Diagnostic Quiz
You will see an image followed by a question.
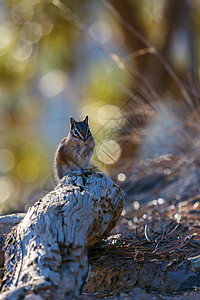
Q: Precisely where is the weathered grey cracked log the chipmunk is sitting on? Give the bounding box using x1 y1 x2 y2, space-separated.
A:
1 170 124 299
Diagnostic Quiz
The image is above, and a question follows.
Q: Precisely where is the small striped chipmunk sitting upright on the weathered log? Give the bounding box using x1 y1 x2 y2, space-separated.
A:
54 116 95 182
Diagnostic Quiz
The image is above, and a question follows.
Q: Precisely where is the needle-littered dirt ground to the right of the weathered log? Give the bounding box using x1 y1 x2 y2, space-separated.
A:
84 155 200 299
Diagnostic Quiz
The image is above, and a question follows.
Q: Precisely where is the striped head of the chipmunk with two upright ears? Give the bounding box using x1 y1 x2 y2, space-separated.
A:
70 115 93 142
